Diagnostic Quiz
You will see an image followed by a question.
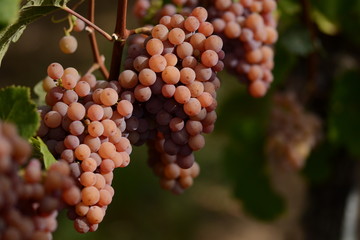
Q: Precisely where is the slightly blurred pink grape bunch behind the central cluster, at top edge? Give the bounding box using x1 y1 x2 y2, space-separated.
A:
134 0 278 97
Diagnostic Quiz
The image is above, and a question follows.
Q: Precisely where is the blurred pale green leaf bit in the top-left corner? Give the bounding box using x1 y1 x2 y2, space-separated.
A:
0 0 20 31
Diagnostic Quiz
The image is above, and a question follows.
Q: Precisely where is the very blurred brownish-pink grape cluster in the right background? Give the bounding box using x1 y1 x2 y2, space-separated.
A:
267 92 322 169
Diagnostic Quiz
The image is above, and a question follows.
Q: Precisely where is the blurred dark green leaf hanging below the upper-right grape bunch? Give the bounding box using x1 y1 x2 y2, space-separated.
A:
217 89 285 220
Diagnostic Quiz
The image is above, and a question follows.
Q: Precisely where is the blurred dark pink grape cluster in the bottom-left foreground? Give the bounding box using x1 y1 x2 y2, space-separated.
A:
0 122 79 240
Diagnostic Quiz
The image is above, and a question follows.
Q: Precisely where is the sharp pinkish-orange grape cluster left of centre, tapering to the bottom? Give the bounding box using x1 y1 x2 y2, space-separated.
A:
38 63 133 233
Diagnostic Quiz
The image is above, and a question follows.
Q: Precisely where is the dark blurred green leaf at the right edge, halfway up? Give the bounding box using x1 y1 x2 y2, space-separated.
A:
328 71 360 156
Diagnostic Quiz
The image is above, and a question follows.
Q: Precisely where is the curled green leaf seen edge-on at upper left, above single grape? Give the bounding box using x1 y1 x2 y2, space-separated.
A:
0 0 69 66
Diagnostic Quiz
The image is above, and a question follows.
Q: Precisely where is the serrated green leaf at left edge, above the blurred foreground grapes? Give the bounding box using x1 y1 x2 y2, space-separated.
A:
0 86 40 139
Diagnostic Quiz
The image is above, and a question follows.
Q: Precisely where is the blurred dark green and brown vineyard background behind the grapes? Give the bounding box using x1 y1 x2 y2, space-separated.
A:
0 0 360 240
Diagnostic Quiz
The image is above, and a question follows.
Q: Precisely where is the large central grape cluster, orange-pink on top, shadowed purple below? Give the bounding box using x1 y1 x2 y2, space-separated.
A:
119 7 221 192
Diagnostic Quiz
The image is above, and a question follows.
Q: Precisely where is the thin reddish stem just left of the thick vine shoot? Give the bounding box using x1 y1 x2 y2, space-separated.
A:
88 0 109 79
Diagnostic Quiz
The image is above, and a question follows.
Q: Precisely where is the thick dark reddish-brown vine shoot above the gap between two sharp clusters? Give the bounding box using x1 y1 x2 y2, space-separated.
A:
108 0 130 80
